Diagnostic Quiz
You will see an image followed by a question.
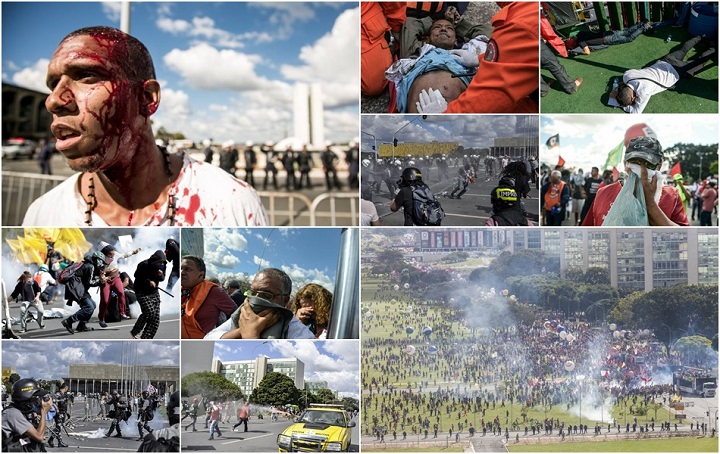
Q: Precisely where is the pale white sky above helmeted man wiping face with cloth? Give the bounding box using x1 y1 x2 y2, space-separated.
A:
540 115 718 172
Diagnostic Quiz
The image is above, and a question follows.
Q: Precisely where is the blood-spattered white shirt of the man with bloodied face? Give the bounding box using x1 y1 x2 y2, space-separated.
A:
22 155 268 227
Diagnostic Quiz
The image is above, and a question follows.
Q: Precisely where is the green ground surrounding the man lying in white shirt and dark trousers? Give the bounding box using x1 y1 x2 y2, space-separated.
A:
541 27 718 114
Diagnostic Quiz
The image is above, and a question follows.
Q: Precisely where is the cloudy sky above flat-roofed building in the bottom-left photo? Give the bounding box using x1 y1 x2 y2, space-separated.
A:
2 340 180 380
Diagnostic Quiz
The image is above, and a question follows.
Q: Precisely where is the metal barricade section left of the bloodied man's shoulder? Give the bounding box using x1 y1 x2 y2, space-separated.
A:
2 171 67 226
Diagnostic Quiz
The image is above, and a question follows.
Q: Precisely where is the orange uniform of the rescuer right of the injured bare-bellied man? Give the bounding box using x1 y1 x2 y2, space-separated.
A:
445 2 539 113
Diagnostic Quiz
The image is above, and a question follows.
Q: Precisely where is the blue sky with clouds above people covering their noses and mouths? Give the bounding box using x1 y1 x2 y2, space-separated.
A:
197 228 342 291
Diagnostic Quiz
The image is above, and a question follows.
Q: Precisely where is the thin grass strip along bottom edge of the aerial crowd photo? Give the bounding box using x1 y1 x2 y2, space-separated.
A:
508 437 718 452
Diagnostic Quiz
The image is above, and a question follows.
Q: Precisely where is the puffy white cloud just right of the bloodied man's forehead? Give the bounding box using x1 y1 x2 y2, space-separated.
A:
163 43 272 91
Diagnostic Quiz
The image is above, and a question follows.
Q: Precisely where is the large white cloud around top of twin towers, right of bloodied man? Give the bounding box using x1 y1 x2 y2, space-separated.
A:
281 8 360 107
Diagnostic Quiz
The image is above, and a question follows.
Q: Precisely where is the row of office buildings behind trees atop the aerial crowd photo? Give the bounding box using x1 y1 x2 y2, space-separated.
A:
415 227 718 291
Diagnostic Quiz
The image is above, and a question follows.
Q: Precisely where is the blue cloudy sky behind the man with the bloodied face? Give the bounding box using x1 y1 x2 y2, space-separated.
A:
2 2 360 143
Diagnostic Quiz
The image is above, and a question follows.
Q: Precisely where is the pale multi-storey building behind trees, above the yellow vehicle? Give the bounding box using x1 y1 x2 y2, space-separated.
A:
211 356 305 396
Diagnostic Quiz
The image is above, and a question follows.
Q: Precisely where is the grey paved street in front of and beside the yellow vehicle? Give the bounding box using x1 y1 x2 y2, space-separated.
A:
181 417 360 452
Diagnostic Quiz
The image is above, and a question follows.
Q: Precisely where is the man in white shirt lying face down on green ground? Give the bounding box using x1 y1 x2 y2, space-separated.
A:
610 36 715 113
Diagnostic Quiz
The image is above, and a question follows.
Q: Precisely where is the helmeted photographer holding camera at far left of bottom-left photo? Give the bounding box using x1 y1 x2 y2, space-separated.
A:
2 378 53 452
